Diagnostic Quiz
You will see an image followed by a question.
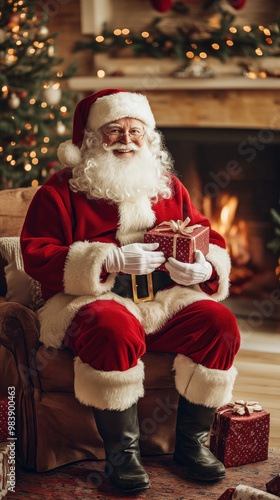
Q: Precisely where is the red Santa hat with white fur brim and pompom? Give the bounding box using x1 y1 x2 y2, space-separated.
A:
57 89 155 167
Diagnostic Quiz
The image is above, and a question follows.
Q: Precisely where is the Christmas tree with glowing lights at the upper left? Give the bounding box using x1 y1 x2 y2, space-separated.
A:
0 0 79 189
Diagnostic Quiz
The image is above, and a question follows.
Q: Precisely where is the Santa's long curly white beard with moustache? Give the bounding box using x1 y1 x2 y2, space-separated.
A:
69 143 171 203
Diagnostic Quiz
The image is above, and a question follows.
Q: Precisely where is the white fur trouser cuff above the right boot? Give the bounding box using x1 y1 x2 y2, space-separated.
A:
174 354 237 408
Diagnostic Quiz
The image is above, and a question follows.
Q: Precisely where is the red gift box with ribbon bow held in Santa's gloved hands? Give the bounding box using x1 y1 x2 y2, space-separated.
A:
144 217 209 272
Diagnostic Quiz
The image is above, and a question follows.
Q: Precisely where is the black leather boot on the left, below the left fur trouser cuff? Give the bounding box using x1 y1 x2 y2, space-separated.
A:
93 403 150 493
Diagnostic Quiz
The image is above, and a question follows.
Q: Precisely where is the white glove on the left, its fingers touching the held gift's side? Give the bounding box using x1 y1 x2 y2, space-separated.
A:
105 243 165 274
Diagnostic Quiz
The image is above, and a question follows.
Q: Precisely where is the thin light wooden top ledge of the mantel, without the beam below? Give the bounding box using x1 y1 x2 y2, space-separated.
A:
69 74 280 92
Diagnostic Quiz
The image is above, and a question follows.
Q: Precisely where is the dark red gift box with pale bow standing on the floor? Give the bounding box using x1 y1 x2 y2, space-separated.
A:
210 401 270 467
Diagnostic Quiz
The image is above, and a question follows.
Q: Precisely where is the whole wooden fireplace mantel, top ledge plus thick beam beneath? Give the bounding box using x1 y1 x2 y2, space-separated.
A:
69 75 280 130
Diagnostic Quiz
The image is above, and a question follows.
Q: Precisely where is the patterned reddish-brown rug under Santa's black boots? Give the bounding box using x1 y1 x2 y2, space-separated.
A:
6 450 280 500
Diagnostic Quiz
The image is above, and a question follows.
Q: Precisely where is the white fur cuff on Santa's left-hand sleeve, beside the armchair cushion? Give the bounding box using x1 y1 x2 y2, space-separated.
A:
63 241 115 296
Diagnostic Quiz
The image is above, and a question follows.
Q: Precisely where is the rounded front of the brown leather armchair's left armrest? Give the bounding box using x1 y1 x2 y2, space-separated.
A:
0 302 40 469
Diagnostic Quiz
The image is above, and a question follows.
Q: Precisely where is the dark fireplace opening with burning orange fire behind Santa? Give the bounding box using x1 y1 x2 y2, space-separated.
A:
161 127 280 328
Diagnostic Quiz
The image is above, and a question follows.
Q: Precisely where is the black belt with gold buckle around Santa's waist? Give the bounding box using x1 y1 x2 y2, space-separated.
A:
112 271 175 302
